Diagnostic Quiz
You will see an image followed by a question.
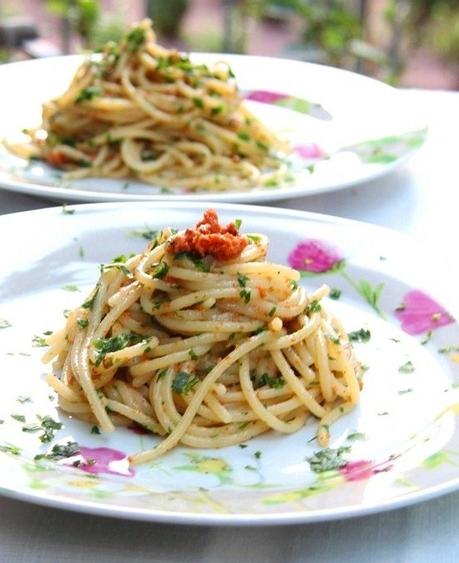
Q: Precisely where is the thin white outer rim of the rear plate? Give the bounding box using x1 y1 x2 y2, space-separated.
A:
0 51 429 203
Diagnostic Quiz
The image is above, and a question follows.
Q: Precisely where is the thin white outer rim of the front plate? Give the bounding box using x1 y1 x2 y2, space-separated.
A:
0 201 459 526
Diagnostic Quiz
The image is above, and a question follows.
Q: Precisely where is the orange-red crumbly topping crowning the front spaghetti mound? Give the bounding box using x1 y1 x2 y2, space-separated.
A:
168 209 248 260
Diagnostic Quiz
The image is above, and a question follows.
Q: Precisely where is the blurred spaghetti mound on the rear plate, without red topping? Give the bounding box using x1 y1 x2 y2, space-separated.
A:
8 20 289 191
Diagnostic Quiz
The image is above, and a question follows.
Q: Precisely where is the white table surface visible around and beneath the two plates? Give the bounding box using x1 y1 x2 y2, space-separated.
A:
0 90 459 563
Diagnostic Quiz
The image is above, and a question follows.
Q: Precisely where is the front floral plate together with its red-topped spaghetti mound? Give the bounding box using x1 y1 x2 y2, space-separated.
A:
0 202 459 525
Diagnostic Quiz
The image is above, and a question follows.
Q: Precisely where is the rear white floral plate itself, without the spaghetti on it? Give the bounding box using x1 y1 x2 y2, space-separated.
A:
0 54 426 202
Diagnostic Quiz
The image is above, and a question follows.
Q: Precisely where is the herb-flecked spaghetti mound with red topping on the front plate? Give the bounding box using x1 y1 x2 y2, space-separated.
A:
45 210 361 463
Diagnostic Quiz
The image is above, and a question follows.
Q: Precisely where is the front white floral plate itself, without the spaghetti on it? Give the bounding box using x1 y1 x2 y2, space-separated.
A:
0 202 459 525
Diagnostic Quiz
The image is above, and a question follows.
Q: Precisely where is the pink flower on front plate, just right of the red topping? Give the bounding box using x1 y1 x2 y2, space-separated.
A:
287 239 342 273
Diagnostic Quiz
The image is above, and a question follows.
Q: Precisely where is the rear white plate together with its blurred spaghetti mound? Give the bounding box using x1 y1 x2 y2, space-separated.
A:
0 20 426 201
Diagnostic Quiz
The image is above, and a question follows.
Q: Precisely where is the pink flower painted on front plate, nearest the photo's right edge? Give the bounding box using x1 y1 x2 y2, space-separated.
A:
395 289 454 334
